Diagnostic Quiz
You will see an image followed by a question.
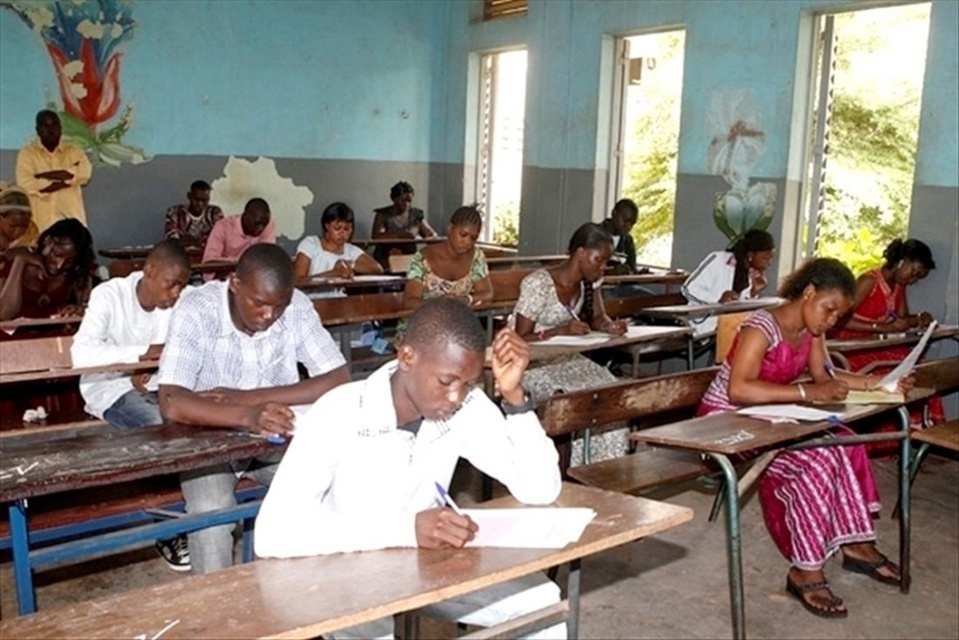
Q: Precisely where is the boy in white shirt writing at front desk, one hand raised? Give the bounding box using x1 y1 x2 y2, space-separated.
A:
255 298 566 638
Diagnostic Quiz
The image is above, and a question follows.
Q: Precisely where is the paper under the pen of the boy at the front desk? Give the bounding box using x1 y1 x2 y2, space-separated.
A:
463 507 596 549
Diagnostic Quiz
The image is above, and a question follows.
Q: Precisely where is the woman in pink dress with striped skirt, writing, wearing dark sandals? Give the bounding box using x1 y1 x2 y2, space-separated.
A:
699 258 911 618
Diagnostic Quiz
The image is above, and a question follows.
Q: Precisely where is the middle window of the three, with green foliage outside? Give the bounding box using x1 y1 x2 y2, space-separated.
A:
606 30 686 266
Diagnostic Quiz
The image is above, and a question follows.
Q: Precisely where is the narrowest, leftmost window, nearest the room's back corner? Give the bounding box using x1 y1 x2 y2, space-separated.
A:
467 50 526 246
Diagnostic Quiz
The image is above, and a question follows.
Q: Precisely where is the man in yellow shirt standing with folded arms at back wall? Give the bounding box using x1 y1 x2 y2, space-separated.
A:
17 110 93 233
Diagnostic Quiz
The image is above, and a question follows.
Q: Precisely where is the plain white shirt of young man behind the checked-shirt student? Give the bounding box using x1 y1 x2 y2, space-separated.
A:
70 271 173 419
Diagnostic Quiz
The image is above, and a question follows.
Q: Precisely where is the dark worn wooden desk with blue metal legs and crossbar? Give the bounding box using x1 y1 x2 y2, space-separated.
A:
0 425 283 612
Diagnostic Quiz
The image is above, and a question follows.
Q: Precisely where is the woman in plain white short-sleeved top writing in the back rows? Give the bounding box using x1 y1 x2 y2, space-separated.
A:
293 202 383 295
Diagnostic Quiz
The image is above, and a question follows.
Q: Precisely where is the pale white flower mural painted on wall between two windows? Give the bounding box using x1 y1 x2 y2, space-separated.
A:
706 90 776 243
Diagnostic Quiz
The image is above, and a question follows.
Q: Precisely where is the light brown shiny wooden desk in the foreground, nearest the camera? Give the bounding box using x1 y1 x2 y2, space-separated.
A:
0 484 693 639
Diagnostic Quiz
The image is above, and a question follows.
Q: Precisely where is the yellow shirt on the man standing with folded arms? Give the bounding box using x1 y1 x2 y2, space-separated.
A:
17 140 93 233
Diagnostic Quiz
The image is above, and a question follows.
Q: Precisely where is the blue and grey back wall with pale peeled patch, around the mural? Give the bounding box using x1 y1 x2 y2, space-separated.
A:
0 0 444 247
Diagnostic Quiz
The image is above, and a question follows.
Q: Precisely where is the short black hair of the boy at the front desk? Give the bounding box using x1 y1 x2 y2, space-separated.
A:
403 296 486 353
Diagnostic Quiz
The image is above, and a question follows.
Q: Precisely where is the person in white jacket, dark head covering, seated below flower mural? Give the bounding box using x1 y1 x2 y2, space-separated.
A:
682 229 776 334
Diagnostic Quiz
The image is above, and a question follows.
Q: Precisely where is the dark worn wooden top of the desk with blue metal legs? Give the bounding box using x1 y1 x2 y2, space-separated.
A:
0 424 284 502
